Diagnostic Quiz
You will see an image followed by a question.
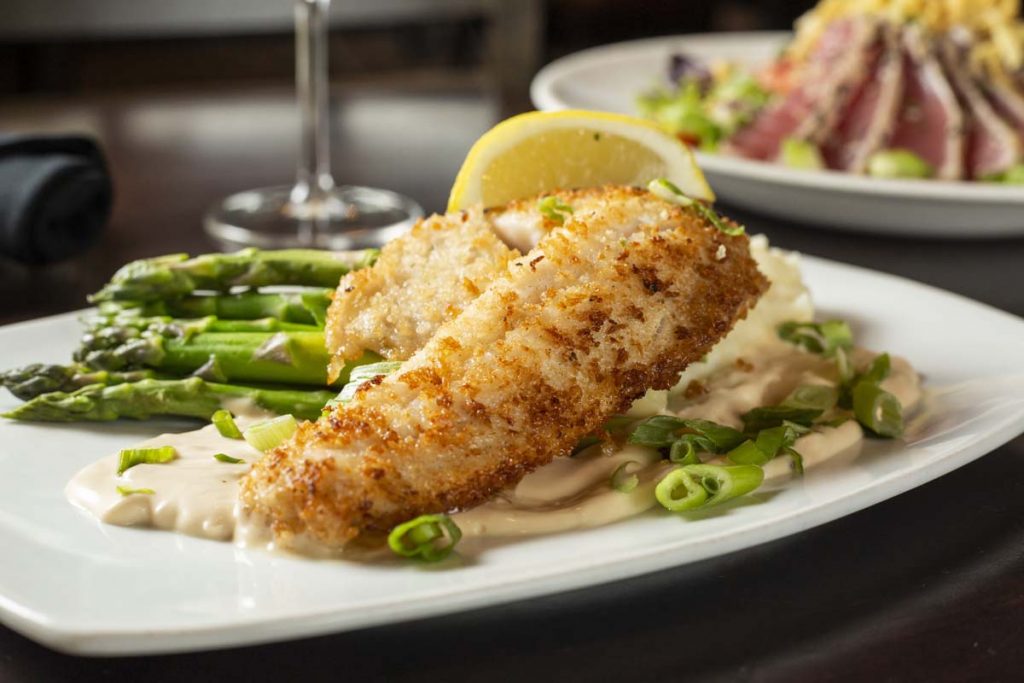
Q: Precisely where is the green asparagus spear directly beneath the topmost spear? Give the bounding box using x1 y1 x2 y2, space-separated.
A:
99 289 332 327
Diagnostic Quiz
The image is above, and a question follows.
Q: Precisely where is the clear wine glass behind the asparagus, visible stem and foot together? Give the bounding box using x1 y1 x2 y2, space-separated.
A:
204 0 423 250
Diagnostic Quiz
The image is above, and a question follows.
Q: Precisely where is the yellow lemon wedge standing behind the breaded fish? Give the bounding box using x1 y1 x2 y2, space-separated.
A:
447 110 715 211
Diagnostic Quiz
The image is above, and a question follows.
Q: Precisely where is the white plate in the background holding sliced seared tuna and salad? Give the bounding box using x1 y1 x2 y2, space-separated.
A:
530 32 1024 238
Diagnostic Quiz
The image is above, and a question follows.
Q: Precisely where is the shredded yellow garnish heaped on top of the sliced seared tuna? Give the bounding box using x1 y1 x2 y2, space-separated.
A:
787 0 1024 75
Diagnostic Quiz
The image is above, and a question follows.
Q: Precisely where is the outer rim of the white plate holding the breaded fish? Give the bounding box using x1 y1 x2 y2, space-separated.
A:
0 255 1024 655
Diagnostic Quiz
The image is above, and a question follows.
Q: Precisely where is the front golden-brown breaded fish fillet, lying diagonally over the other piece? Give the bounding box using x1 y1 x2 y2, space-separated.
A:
241 187 767 547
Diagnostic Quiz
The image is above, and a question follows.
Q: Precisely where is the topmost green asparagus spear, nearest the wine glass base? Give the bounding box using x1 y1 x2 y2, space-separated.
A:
89 249 378 303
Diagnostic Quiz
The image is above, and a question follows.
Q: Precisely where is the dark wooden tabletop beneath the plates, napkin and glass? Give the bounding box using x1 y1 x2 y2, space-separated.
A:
0 89 1024 683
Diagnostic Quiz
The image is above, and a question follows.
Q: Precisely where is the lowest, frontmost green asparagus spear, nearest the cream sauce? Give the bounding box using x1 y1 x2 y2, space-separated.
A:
3 377 336 422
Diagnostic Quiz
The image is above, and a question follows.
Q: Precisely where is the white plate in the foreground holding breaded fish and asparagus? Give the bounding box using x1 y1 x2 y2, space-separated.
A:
0 258 1024 654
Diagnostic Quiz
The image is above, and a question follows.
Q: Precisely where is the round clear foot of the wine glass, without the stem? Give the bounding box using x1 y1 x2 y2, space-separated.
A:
203 185 423 251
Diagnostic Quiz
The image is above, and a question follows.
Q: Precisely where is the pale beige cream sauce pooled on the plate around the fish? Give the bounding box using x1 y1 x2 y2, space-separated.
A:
67 342 921 555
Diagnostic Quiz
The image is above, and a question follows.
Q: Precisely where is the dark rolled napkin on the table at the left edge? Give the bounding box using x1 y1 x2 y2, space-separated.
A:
0 133 114 264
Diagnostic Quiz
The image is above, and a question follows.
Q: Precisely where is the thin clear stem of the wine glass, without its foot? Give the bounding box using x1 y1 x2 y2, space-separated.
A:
292 0 334 204
